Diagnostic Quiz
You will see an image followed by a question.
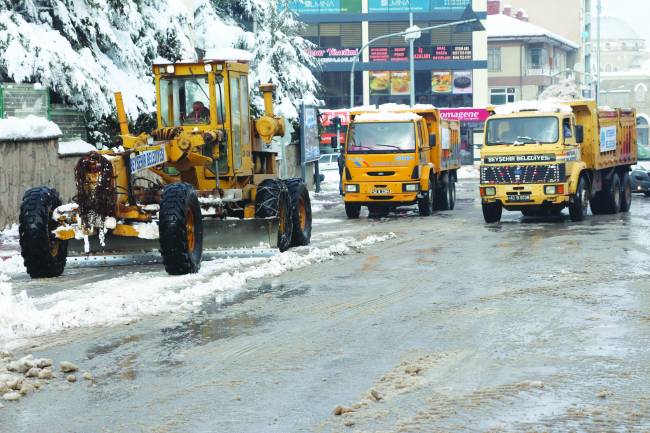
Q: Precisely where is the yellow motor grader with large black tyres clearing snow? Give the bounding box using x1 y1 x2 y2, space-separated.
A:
19 54 311 278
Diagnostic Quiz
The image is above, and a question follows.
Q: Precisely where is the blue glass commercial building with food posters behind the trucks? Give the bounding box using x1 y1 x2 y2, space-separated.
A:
291 0 487 109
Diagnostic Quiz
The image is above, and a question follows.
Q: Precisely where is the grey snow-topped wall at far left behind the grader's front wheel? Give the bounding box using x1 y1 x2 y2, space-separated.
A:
0 138 79 229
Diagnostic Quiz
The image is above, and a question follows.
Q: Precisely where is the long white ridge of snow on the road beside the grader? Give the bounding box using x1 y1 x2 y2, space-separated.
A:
0 233 395 348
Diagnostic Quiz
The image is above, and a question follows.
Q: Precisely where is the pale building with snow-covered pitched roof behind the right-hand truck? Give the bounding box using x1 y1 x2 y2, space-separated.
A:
486 8 579 104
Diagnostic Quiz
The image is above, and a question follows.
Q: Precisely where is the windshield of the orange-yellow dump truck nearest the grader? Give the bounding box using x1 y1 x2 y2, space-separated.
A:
347 122 415 153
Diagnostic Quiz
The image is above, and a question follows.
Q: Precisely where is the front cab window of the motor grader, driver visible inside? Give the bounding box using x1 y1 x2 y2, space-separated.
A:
160 74 222 126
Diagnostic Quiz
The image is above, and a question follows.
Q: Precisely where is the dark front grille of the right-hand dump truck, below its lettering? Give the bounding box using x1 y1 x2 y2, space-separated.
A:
481 164 566 184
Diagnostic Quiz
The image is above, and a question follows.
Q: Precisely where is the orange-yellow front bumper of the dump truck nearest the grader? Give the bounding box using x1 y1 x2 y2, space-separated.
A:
343 180 420 205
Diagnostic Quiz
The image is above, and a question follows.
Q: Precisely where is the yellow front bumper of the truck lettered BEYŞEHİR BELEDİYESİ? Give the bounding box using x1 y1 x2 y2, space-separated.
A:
480 183 571 209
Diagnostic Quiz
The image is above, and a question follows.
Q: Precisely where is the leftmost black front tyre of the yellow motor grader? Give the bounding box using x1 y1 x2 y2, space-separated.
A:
18 186 68 278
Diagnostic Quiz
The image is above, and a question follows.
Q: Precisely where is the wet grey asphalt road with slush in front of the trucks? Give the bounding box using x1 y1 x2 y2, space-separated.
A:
0 177 650 433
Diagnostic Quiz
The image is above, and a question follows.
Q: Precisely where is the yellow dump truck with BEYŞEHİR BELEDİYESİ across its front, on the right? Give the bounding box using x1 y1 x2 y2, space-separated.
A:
480 101 637 223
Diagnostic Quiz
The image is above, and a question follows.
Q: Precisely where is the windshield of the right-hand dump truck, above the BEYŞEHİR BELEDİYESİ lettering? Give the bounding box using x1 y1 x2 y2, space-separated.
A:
486 116 559 146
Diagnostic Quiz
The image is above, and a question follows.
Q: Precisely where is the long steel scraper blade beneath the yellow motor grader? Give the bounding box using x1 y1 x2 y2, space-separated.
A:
68 218 278 256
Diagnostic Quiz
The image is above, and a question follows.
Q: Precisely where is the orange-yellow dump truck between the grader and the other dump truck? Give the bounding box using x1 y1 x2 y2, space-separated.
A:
341 106 460 218
